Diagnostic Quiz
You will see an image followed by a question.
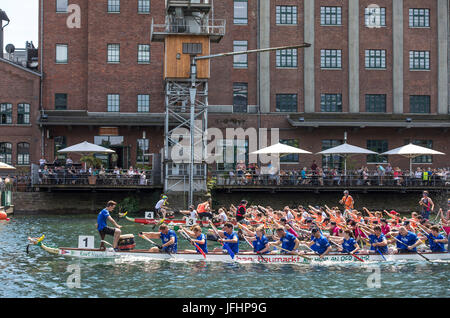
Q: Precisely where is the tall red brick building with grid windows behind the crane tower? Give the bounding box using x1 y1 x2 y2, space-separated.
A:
19 0 450 176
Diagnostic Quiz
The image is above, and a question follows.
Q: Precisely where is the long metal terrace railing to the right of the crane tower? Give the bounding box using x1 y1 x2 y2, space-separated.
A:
212 171 450 188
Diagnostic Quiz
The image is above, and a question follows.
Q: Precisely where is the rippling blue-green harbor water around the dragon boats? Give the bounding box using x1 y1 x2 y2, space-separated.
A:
0 215 450 298
